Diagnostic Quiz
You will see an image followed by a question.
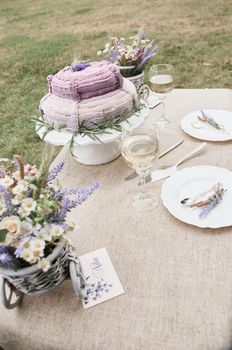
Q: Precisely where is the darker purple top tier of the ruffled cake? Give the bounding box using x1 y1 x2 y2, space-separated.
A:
47 61 123 102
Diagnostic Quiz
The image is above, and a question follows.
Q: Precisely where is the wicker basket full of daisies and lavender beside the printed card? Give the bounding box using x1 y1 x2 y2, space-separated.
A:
0 156 98 308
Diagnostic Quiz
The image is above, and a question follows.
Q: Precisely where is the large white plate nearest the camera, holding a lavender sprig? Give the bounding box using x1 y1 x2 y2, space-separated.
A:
161 165 232 228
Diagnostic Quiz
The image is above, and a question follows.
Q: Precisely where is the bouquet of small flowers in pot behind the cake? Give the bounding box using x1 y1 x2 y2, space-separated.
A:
97 30 157 87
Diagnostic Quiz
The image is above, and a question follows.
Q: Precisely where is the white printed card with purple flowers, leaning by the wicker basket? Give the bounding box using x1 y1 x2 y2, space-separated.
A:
79 248 125 309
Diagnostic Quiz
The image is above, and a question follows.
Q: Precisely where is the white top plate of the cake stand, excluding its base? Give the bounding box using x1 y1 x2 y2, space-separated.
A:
36 105 149 146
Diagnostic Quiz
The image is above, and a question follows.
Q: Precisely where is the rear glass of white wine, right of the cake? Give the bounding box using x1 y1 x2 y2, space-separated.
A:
150 64 174 128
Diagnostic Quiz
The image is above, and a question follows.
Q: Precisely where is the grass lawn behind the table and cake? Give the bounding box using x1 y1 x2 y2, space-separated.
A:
0 0 232 164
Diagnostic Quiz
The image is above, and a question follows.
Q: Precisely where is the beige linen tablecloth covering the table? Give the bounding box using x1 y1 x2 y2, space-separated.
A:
0 89 232 350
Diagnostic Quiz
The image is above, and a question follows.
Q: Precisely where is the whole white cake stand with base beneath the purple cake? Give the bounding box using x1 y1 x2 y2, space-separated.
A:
36 106 149 165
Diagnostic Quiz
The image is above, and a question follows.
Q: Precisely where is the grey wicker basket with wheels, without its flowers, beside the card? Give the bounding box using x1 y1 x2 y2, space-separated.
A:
0 241 84 309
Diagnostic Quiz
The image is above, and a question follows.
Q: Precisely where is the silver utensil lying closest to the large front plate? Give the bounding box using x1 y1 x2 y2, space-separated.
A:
139 142 207 185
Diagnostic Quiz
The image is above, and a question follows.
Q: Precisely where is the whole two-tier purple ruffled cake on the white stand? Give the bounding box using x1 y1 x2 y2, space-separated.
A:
40 61 136 132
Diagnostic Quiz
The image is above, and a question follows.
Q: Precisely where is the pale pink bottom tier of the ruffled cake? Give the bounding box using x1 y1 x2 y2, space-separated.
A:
40 78 136 132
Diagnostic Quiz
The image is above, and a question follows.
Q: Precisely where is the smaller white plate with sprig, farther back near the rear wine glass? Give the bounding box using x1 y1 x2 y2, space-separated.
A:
181 109 232 141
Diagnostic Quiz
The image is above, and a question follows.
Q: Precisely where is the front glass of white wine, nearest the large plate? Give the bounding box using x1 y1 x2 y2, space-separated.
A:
122 122 159 212
